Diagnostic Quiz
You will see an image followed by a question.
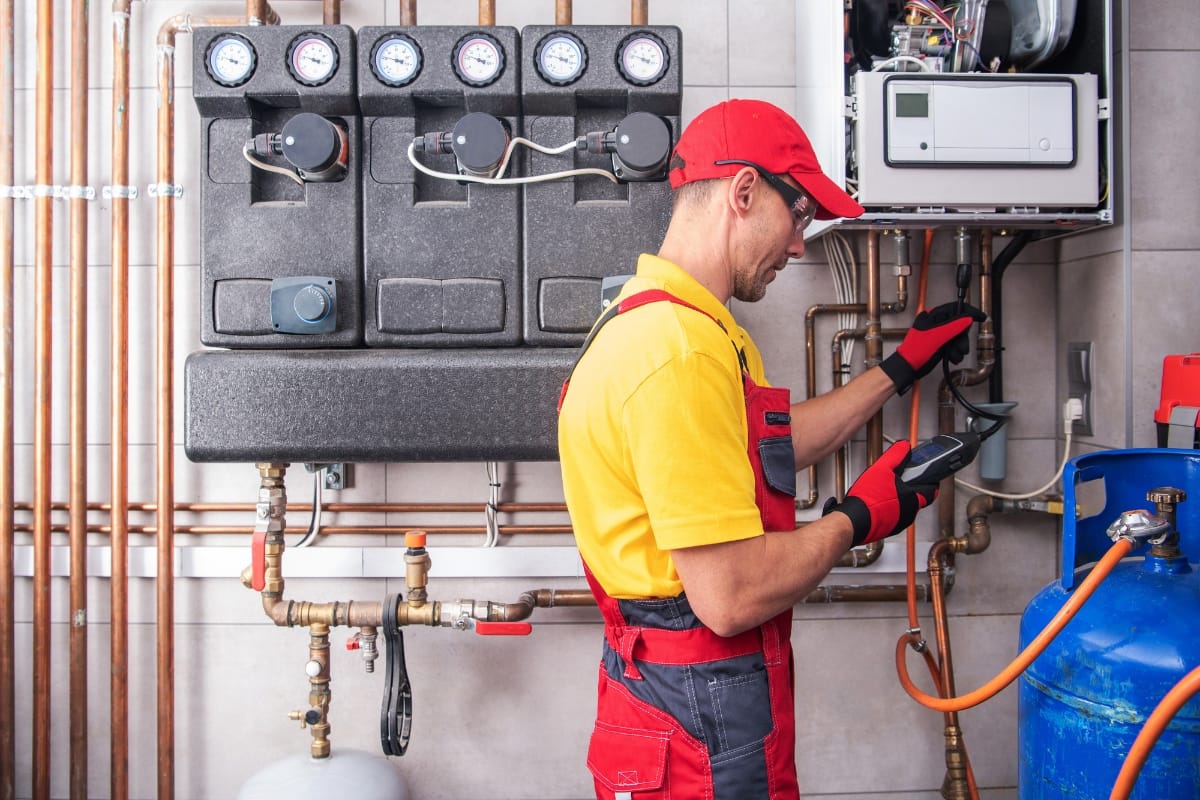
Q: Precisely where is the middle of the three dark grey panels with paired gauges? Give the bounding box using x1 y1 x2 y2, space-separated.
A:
358 25 521 348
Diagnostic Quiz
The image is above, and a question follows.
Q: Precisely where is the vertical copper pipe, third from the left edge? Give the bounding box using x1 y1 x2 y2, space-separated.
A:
68 0 88 786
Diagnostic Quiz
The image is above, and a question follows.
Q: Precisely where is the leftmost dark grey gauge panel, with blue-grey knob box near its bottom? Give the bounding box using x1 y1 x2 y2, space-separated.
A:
192 25 362 348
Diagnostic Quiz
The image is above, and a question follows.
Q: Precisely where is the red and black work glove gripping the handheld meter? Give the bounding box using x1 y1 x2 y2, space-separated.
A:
822 441 937 547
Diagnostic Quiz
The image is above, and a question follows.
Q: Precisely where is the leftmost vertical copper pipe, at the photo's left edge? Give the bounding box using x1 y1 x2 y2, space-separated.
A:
0 0 17 800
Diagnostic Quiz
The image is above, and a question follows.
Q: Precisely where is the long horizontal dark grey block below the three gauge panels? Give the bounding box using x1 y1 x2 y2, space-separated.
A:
184 348 576 462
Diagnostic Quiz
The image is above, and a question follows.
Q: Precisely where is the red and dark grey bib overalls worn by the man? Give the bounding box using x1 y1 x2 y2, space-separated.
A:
559 290 799 800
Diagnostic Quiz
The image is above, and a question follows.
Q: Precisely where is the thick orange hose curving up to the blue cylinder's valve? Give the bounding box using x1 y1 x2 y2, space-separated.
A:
896 539 1133 711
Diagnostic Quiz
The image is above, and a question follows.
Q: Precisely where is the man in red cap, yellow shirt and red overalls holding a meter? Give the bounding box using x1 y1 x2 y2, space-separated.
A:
559 100 982 800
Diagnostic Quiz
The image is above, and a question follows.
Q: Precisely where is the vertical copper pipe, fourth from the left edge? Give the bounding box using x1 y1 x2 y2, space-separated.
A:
108 0 132 800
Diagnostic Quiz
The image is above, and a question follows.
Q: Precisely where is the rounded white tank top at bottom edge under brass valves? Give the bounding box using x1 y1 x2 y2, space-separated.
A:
238 748 413 800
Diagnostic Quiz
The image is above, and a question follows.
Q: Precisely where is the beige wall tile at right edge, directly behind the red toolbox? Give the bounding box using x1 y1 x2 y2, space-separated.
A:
1130 251 1200 447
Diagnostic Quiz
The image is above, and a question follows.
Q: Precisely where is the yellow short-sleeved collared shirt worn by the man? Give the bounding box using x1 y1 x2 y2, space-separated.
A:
558 254 766 599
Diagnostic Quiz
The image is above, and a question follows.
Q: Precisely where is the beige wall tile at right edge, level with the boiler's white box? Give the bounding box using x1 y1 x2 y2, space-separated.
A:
1130 50 1200 251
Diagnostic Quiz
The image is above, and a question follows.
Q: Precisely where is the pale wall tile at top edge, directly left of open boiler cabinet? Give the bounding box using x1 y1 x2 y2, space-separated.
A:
728 0 796 86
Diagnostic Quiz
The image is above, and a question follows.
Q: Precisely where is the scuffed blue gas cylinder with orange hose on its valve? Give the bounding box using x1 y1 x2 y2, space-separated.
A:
1018 450 1200 800
